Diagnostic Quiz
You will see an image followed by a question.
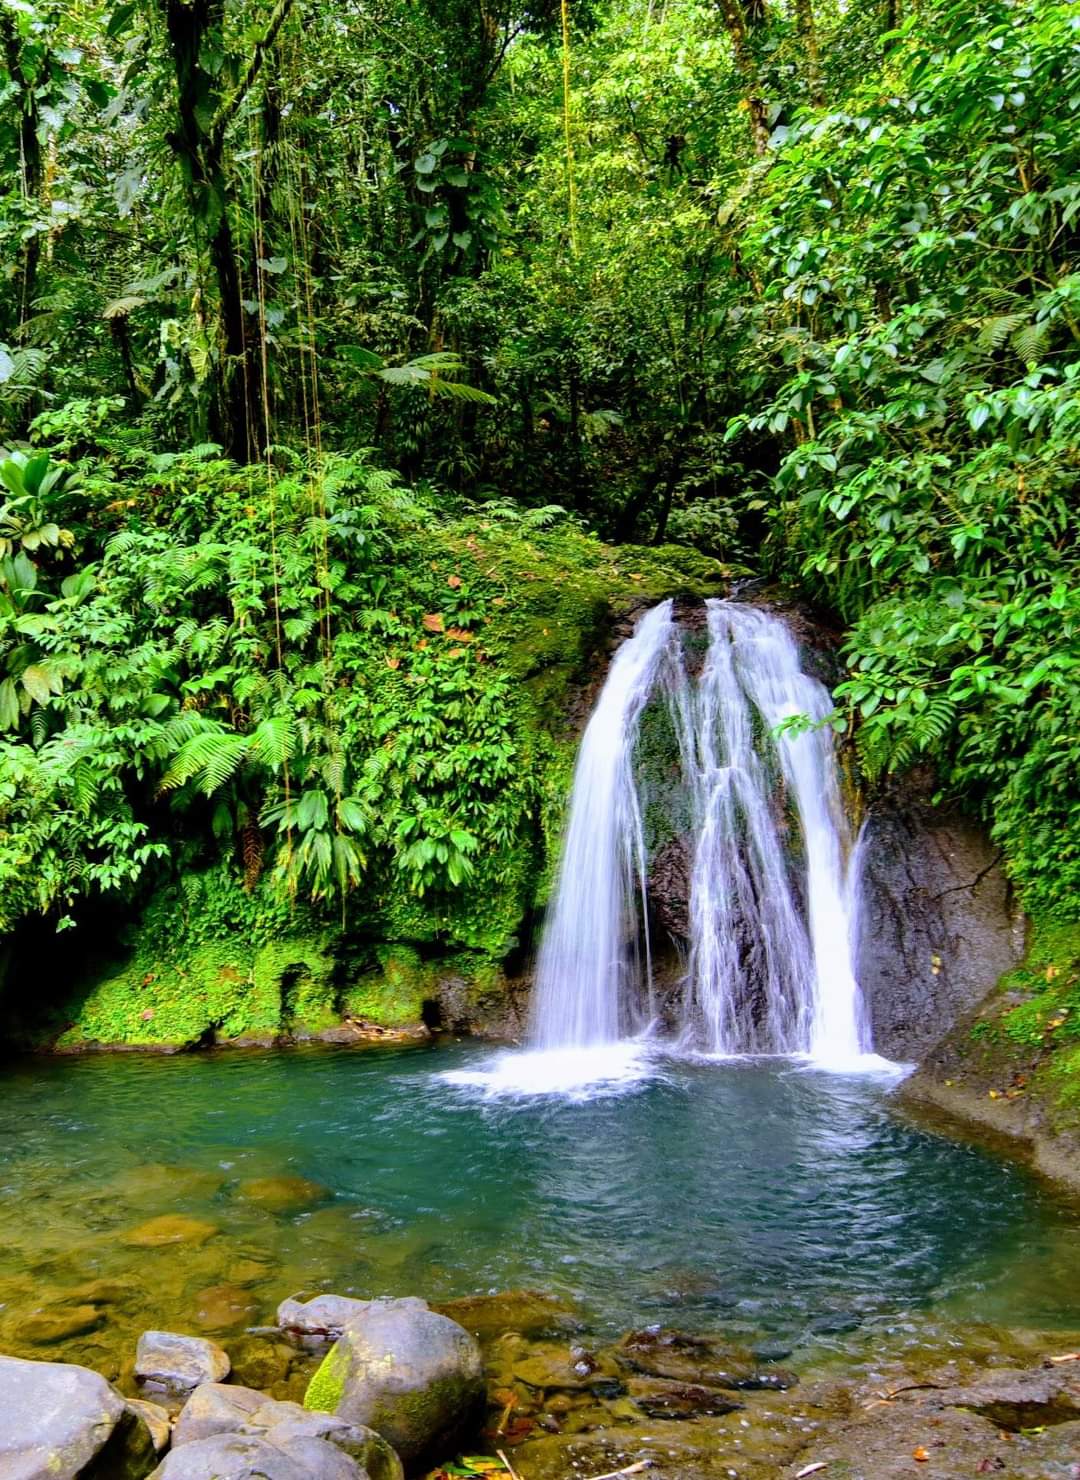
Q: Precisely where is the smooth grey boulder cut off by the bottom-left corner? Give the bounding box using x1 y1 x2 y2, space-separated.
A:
0 1357 154 1480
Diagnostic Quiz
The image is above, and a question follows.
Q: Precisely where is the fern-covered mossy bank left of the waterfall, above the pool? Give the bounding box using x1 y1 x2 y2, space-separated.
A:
0 435 725 1043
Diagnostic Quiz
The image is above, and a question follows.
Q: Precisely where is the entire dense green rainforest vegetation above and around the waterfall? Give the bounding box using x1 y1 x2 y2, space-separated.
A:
0 0 1080 1032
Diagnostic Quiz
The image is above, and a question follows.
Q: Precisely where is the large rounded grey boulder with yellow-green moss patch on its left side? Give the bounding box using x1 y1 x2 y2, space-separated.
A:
305 1299 484 1465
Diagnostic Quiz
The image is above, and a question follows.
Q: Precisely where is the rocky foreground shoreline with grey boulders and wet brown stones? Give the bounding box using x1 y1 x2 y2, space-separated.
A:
0 1291 1080 1480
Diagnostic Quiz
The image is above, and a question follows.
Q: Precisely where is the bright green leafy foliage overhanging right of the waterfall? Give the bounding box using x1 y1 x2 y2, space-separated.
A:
728 3 1080 919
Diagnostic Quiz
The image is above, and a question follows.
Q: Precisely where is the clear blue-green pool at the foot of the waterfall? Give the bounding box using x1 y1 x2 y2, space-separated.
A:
0 1045 1080 1362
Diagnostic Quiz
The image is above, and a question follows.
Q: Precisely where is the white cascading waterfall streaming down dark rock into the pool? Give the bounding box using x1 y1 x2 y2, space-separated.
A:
530 601 870 1063
